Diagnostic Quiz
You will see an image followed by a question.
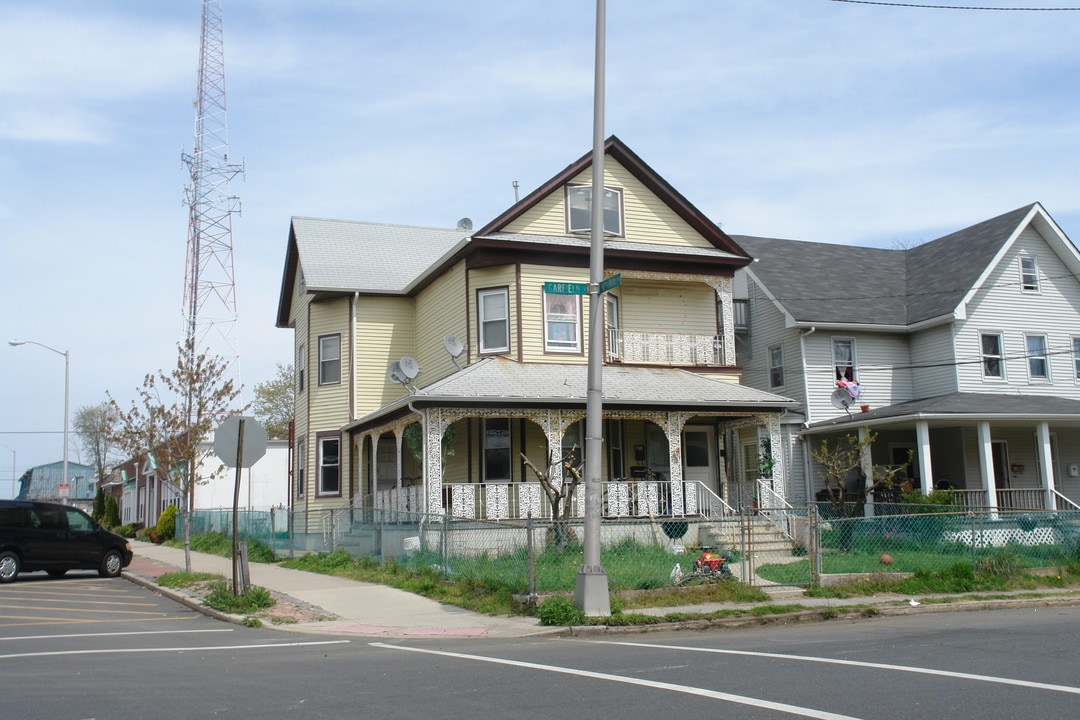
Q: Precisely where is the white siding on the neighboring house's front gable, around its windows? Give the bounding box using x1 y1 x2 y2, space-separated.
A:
956 228 1080 399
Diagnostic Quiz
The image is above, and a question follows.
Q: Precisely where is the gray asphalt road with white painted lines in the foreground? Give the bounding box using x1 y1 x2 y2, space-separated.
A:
0 576 1080 720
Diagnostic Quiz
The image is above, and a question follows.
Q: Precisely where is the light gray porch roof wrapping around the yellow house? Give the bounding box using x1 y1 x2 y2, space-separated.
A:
345 357 797 431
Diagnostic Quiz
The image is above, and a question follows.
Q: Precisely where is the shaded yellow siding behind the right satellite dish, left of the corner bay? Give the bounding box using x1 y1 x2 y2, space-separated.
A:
415 262 469 386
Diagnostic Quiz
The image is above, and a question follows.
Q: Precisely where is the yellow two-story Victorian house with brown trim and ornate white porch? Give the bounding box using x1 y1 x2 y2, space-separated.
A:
278 137 794 539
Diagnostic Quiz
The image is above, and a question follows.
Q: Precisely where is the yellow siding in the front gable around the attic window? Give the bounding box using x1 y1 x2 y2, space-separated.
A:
507 158 712 247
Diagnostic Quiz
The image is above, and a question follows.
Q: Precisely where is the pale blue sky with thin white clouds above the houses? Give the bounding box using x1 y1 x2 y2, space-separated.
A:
0 0 1080 497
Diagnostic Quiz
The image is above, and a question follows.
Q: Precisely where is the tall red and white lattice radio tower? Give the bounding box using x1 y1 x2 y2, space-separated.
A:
181 0 244 395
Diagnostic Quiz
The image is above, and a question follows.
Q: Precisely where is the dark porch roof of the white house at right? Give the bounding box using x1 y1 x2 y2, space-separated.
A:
804 393 1080 435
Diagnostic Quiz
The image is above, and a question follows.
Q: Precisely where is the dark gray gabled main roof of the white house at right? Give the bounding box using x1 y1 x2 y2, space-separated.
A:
733 203 1080 329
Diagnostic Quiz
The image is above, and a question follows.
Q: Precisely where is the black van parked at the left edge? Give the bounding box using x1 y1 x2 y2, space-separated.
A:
0 500 132 583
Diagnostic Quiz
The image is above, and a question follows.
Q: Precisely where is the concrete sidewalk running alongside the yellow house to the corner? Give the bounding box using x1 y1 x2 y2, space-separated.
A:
124 541 562 638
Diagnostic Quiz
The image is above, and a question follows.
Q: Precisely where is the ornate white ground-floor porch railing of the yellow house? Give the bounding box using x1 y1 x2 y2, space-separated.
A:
370 479 735 520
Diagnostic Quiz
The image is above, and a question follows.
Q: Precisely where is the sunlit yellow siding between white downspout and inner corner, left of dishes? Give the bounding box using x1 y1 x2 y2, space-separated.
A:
356 297 416 417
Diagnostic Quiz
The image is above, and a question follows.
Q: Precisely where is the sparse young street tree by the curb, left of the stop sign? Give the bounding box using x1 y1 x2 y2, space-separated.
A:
109 340 241 572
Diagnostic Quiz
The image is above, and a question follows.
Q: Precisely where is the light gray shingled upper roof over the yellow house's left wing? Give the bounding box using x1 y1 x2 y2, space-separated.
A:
293 217 469 294
